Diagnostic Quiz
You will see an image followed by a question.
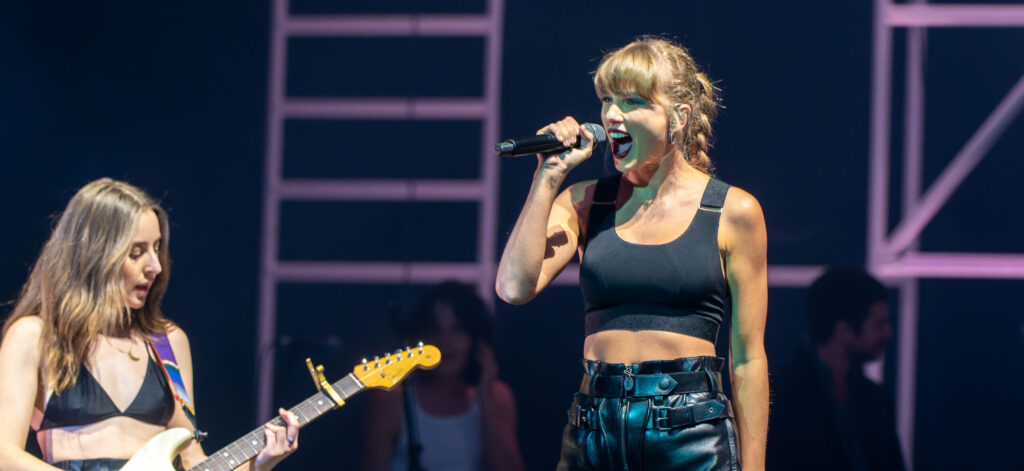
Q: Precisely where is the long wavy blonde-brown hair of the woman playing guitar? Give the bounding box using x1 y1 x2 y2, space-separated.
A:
3 178 170 393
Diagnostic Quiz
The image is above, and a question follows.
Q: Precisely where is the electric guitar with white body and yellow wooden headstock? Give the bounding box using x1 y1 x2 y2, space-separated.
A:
120 343 441 471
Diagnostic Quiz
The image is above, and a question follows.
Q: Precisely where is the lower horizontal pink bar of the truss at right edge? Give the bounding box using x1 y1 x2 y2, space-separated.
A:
874 253 1024 280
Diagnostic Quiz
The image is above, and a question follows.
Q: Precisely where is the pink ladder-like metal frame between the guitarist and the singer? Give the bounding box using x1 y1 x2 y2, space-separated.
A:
255 0 505 418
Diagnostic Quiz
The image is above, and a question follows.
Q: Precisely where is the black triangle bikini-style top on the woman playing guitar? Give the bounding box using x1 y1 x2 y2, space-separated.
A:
39 357 174 430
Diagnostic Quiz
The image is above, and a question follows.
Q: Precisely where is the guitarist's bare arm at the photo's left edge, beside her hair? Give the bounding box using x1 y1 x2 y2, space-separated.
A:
0 315 57 471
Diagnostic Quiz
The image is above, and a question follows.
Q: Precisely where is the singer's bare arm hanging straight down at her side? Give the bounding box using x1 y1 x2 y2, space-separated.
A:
719 187 768 471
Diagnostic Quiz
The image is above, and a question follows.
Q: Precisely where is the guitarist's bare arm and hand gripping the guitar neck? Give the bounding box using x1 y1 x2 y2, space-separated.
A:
167 326 299 471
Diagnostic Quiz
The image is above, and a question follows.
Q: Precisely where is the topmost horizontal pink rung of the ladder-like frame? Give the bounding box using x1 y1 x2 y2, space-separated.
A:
285 14 493 37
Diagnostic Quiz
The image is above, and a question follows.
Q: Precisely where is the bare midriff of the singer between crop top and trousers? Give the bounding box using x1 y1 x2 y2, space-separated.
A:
583 331 715 363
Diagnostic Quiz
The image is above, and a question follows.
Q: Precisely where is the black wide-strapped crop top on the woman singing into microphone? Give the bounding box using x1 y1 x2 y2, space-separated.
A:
580 175 729 343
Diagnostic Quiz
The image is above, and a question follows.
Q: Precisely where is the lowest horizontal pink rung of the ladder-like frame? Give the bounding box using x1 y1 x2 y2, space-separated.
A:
268 261 480 285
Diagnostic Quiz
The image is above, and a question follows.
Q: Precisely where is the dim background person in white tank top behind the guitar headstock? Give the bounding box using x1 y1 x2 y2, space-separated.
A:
362 282 523 471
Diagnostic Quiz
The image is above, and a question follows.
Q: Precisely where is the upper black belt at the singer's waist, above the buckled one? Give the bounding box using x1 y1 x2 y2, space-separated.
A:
580 372 721 397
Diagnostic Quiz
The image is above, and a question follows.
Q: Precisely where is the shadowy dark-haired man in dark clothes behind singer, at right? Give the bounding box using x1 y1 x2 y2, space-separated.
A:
768 268 903 471
